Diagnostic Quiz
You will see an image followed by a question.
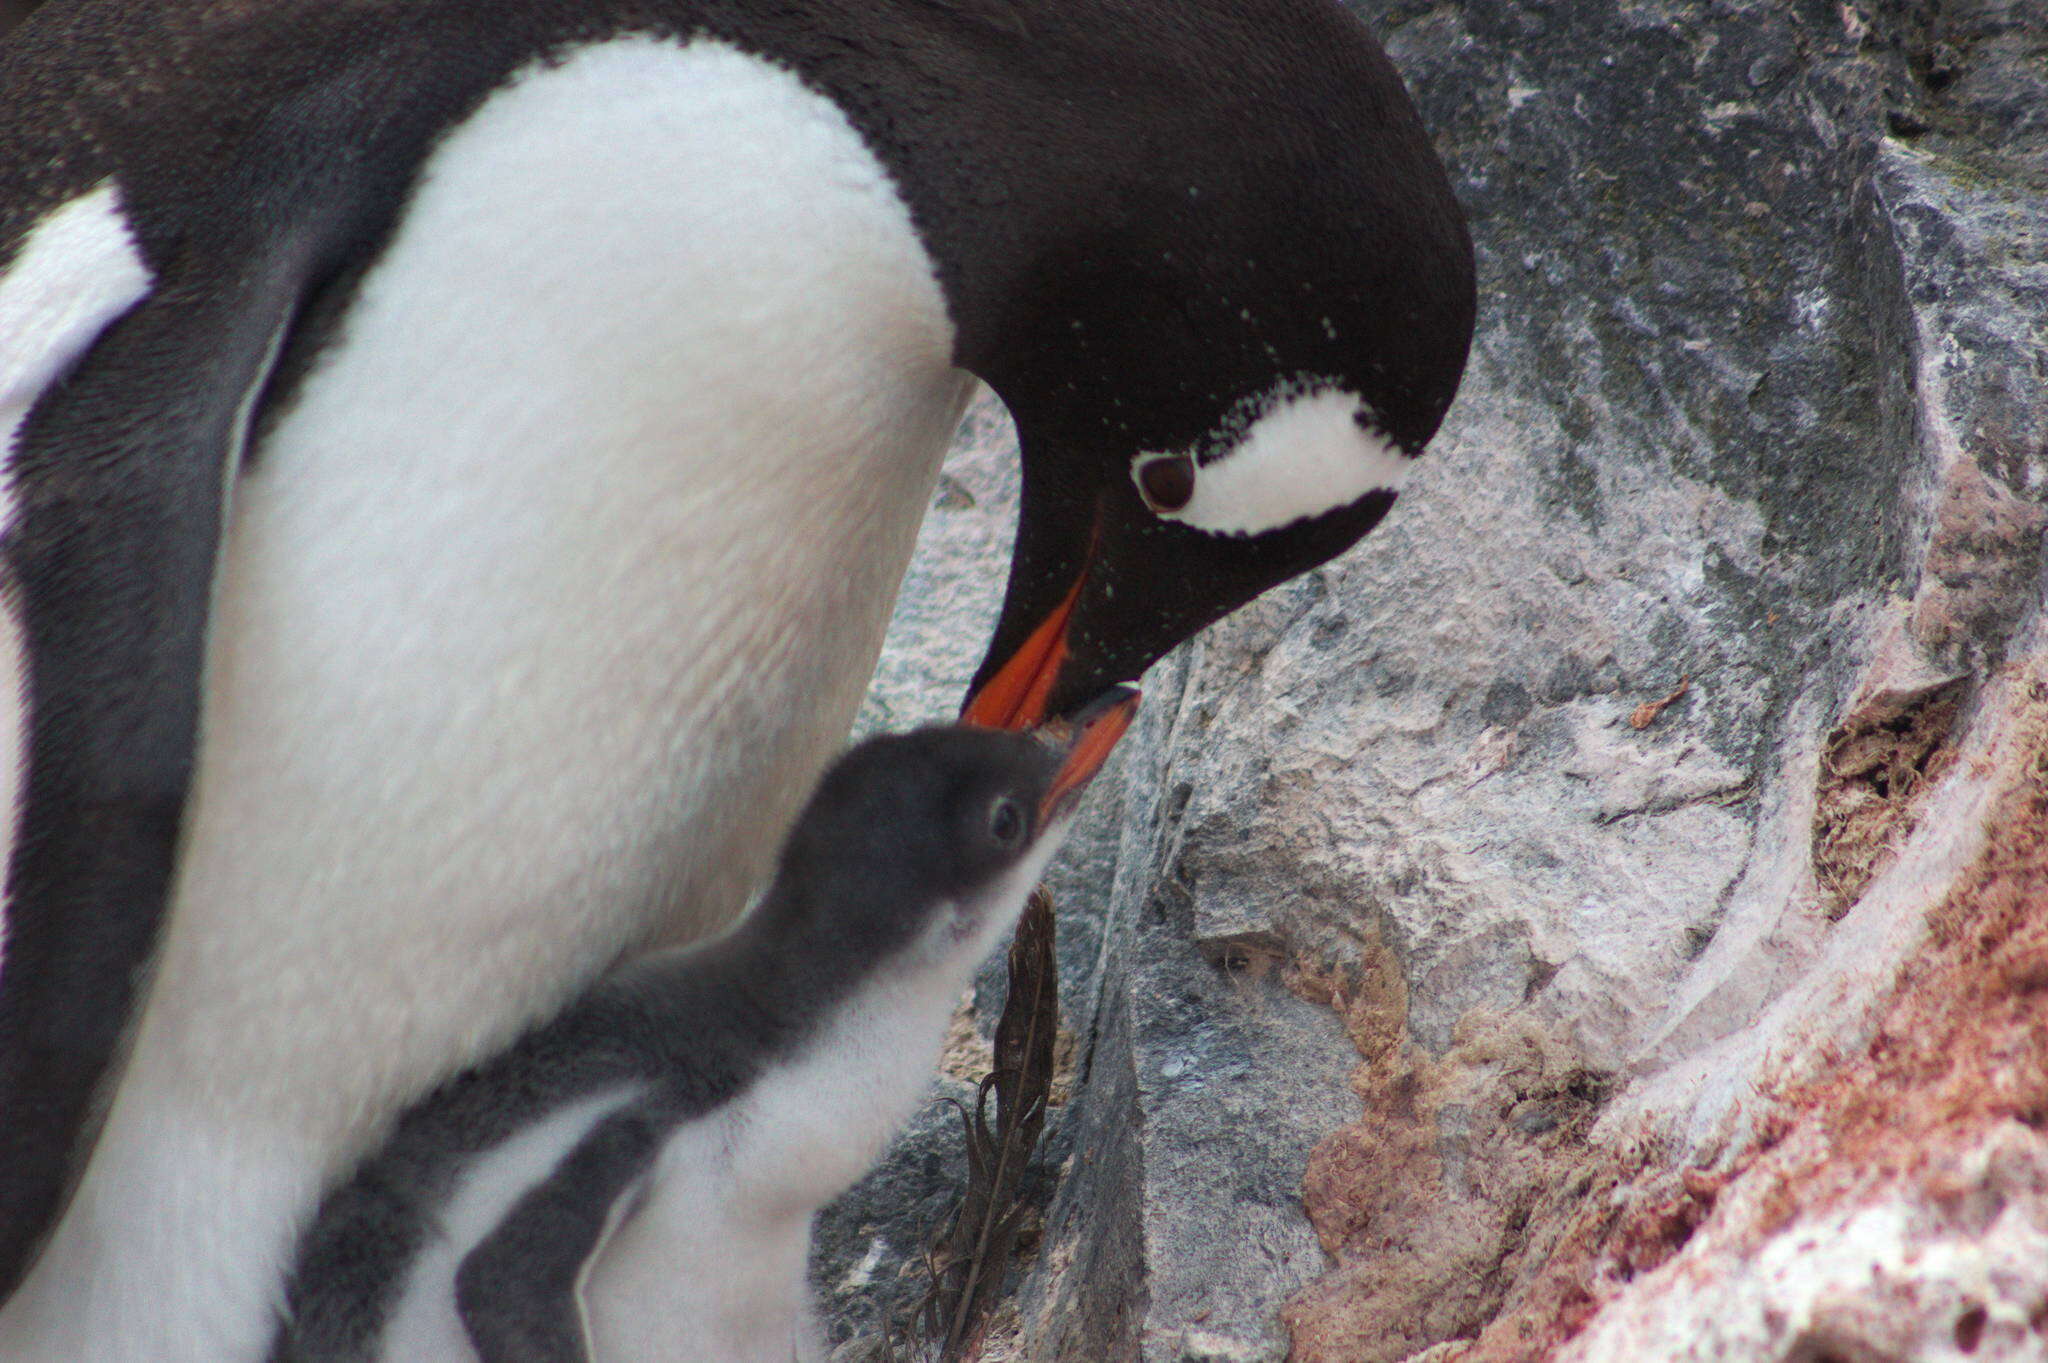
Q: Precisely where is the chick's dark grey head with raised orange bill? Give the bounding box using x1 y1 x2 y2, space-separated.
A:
770 690 1137 968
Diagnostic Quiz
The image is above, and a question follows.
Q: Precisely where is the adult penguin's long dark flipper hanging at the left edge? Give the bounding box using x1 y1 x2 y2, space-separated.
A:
0 251 319 1291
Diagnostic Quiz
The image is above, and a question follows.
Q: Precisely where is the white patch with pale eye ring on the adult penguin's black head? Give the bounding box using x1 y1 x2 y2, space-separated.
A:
1130 387 1411 534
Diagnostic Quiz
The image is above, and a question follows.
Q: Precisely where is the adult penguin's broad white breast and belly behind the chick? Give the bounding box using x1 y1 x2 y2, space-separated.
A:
0 39 967 1363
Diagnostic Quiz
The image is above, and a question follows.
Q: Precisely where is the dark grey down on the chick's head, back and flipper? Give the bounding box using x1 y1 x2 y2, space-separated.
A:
272 729 1059 1363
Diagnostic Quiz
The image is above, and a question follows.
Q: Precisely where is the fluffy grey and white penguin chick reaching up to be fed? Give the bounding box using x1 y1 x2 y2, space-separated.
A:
272 696 1135 1363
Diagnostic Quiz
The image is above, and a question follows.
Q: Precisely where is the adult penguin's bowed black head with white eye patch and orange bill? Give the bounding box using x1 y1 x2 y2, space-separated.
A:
942 0 1475 727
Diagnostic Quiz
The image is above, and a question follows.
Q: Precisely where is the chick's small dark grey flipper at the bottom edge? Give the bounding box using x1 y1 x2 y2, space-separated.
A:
455 1107 664 1363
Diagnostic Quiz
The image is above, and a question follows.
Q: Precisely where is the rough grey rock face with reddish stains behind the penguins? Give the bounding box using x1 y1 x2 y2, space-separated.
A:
819 0 2048 1363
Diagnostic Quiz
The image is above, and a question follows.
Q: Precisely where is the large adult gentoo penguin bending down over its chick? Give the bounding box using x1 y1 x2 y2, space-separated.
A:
0 0 1473 1363
